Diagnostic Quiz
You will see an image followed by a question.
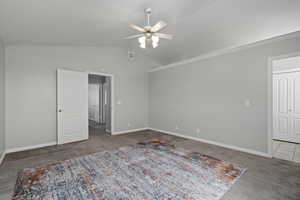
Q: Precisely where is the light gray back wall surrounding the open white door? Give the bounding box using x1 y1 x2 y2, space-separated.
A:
5 46 157 149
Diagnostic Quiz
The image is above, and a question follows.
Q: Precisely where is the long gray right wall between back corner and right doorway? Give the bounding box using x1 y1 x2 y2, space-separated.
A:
149 37 300 152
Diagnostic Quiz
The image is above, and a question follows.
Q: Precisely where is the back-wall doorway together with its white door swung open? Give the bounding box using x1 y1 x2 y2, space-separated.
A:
57 69 114 144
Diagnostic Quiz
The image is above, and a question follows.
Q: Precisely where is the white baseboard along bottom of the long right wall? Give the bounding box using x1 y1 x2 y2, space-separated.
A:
149 128 272 158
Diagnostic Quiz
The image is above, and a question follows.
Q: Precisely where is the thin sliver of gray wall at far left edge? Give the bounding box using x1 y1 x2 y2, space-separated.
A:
0 40 5 158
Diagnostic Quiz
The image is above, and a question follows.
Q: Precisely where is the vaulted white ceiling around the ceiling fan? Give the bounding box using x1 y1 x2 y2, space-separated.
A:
0 0 300 65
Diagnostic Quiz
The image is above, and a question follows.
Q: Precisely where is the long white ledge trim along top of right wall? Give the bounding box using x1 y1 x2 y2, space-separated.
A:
148 31 300 72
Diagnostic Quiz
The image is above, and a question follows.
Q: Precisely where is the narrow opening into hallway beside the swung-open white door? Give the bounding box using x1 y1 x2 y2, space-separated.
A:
88 73 112 138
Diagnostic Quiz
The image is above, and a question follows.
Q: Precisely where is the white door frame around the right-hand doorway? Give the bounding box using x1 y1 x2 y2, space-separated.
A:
267 52 300 157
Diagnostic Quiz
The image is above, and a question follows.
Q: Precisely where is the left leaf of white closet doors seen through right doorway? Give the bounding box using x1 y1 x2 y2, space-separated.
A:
273 73 291 141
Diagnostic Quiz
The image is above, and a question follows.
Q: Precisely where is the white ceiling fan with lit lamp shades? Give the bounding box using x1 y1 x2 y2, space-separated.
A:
124 8 173 49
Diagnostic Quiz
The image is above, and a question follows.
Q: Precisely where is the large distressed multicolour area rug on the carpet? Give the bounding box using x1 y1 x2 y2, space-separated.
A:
12 141 245 200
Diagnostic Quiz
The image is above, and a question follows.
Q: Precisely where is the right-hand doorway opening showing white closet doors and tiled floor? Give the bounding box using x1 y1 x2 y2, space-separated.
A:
272 56 300 162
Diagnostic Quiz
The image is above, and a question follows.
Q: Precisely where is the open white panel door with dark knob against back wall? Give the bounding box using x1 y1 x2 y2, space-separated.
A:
57 69 88 144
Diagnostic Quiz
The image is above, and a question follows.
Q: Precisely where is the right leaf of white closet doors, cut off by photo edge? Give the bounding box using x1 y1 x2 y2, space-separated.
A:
289 72 300 143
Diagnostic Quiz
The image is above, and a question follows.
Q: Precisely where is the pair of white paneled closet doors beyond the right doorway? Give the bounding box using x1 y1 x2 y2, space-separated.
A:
273 72 300 143
